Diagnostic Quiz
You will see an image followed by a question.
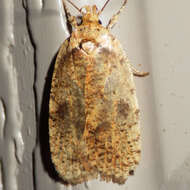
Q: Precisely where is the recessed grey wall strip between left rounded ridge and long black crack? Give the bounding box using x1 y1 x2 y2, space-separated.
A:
14 0 38 190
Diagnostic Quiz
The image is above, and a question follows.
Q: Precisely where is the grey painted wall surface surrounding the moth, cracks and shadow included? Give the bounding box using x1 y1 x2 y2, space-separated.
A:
0 0 190 190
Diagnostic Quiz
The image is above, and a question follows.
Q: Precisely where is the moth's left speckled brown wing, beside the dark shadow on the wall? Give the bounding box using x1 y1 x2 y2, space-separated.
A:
49 40 97 184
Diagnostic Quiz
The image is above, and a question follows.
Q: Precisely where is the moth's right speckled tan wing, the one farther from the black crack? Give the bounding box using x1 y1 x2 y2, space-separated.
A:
85 34 141 184
